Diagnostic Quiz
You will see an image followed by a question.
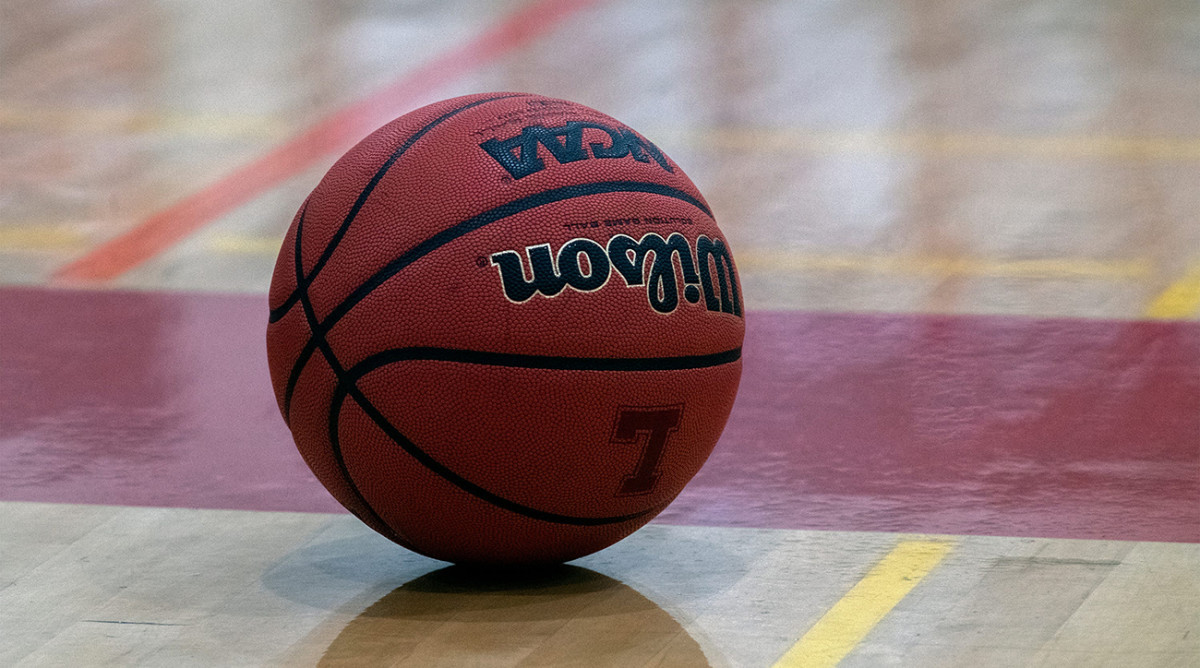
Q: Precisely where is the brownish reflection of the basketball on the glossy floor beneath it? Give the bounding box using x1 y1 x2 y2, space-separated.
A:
319 566 708 668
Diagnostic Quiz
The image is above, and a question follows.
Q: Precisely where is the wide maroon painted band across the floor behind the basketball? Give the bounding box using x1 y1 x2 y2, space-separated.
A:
0 288 1200 542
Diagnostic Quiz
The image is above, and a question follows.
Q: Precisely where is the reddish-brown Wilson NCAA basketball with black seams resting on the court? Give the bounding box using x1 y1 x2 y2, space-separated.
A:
266 92 744 565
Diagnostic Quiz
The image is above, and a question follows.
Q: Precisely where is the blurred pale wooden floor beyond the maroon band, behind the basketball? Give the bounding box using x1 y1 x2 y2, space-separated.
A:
0 0 1200 319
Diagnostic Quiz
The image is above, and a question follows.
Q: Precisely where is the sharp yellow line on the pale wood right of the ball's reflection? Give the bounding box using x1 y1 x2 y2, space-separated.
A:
775 541 953 668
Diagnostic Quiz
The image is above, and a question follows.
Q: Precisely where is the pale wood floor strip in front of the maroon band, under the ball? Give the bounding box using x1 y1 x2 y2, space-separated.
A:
0 502 1200 667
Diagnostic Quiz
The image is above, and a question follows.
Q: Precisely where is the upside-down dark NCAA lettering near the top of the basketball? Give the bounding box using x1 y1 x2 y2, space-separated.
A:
479 121 674 179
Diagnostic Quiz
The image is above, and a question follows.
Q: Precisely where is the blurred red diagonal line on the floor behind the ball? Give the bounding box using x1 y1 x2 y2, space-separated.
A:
53 0 598 283
